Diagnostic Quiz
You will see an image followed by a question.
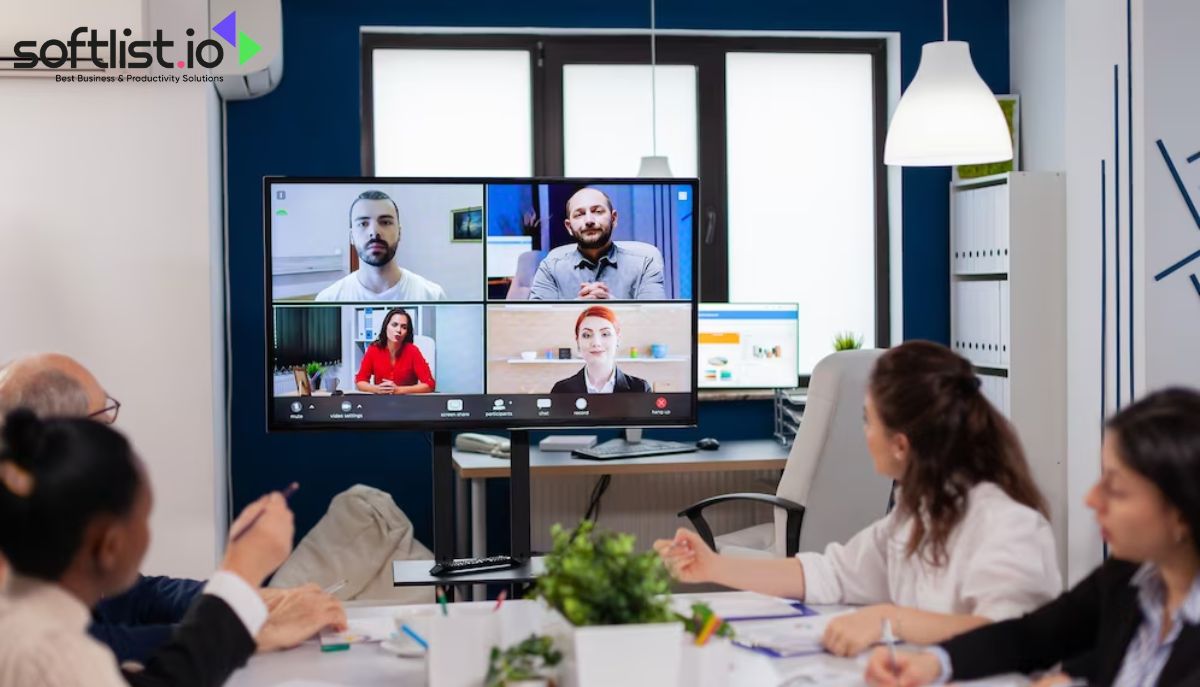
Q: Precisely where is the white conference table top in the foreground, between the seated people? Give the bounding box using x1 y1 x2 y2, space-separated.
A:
228 592 1028 687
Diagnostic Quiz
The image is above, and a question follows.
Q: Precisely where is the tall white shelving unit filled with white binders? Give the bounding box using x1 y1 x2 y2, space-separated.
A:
949 172 1067 569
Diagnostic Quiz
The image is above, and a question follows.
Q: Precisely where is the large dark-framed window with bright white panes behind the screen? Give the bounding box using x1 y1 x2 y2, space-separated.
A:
362 34 890 374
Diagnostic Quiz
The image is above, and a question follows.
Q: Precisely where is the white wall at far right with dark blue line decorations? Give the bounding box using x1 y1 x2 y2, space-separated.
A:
1009 0 1200 581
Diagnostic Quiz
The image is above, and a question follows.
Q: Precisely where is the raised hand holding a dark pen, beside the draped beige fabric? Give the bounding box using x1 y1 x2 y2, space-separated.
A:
221 491 295 587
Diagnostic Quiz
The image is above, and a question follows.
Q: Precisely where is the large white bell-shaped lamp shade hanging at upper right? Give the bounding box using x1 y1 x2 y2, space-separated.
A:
883 41 1013 167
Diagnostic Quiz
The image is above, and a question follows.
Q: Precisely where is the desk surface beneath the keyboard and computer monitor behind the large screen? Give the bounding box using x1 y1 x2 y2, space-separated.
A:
454 438 788 479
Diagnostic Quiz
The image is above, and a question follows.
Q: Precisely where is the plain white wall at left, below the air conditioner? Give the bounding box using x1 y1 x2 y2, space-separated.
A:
0 7 224 577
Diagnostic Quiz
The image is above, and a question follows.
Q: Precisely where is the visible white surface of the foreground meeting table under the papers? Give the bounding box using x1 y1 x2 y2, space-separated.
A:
228 592 1027 687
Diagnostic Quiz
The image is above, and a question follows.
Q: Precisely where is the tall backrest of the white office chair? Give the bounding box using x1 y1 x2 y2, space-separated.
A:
775 350 892 556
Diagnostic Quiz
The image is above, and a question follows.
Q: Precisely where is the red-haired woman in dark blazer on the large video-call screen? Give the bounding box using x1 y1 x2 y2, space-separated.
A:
550 305 650 394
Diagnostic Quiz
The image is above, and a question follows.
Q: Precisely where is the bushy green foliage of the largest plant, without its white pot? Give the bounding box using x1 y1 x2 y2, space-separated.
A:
533 520 678 627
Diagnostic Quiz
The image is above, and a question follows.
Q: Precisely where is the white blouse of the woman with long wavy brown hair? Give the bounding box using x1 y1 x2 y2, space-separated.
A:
796 482 1062 621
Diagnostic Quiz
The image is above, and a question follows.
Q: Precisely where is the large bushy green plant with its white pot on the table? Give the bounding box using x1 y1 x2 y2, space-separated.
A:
533 520 684 687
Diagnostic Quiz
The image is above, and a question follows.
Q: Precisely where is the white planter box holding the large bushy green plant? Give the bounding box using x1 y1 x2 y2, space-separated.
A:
575 622 683 687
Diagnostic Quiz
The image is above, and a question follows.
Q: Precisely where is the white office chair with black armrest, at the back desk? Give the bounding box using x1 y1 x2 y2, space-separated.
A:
679 351 892 557
